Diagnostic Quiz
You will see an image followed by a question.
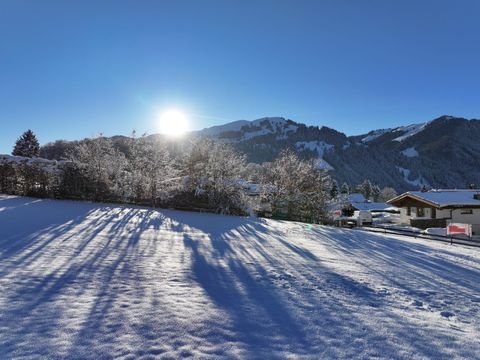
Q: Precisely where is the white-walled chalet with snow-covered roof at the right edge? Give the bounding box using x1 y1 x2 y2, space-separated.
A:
388 190 480 234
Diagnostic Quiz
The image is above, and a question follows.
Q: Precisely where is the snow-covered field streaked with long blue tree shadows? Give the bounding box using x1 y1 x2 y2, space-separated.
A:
0 196 480 359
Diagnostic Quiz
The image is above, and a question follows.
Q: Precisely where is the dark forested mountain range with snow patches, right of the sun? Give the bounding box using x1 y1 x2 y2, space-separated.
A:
195 116 480 191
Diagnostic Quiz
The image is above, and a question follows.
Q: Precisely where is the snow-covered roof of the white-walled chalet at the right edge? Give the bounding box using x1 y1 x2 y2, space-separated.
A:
387 189 480 208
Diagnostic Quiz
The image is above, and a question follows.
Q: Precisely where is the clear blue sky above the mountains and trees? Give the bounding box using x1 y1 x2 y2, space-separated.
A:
0 0 480 153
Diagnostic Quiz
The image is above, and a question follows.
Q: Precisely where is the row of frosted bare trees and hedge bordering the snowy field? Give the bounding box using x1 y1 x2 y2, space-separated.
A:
0 130 352 222
